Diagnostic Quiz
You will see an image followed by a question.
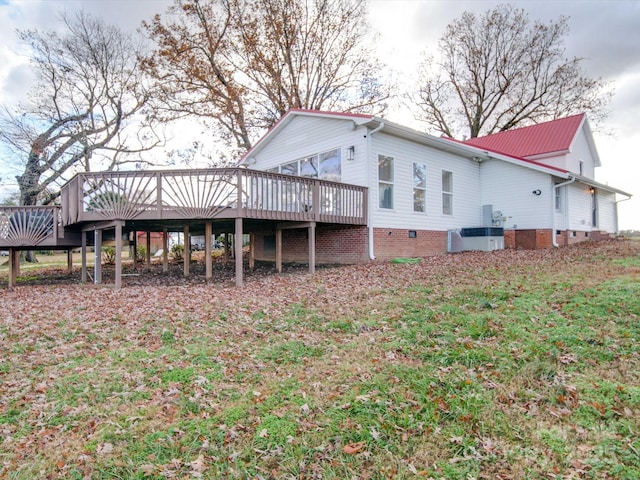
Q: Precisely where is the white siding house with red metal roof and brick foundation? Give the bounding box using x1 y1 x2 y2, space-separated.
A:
241 110 630 262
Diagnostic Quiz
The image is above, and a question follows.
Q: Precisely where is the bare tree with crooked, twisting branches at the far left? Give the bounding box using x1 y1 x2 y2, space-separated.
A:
0 12 160 210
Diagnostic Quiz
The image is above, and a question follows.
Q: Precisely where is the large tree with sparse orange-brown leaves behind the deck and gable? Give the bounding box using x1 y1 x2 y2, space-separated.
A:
144 0 388 157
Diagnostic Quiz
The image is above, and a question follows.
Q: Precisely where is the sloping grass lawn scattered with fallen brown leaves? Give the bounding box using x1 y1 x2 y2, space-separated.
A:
0 241 640 480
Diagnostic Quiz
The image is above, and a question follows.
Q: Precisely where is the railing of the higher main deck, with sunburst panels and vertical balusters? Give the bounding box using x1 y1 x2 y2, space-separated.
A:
61 168 367 225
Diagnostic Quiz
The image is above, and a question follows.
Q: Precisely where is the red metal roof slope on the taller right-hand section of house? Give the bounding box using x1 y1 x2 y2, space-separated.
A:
464 113 584 158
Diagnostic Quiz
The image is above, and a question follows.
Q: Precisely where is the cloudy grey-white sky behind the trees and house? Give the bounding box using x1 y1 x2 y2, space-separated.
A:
0 0 640 229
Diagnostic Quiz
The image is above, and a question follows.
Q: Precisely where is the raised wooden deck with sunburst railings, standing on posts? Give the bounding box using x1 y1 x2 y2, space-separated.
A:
0 168 368 286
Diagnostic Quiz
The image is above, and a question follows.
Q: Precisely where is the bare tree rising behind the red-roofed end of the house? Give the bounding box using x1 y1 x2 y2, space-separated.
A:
413 5 612 137
